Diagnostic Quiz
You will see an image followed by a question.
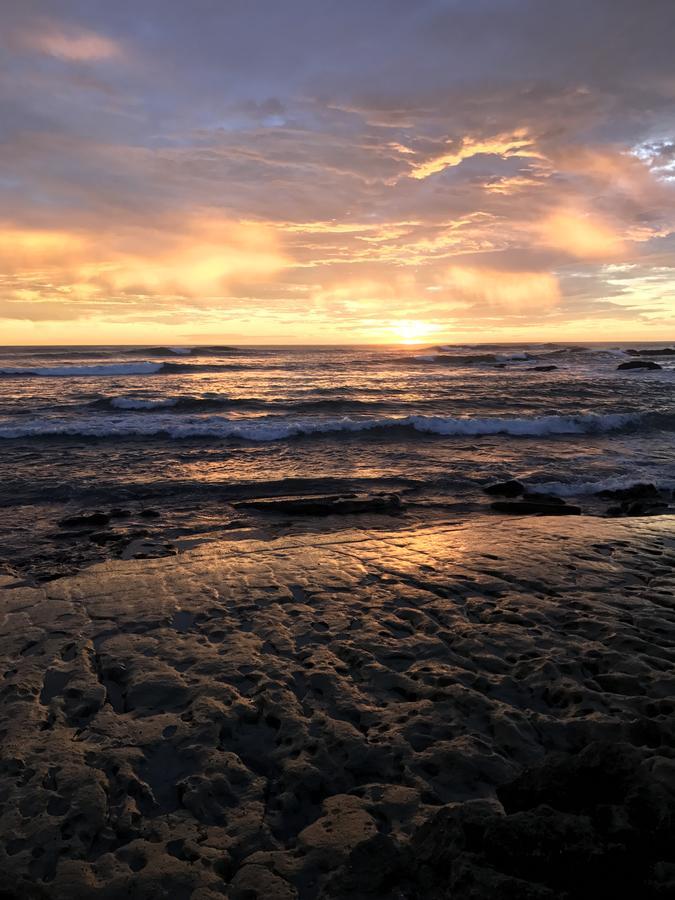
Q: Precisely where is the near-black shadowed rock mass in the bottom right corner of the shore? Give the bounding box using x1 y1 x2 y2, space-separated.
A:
344 729 675 900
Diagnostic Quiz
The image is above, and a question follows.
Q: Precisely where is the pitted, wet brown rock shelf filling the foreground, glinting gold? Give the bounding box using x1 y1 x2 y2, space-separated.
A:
0 516 675 900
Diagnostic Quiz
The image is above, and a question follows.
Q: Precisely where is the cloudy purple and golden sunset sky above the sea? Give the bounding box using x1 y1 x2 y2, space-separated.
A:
0 0 675 344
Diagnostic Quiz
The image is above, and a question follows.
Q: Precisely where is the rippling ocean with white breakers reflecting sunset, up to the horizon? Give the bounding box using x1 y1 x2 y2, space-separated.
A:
0 343 675 578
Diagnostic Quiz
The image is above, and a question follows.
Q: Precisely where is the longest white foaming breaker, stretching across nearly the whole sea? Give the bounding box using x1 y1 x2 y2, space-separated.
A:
0 413 664 441
